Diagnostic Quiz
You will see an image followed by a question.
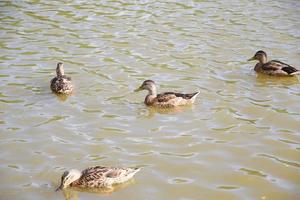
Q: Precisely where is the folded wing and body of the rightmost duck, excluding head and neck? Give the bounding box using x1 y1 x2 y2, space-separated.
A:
262 60 299 74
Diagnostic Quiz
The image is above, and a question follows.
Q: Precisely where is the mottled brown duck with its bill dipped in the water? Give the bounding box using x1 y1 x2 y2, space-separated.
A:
56 166 140 191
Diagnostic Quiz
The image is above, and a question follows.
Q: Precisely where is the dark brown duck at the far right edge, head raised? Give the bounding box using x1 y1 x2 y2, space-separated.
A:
248 50 300 76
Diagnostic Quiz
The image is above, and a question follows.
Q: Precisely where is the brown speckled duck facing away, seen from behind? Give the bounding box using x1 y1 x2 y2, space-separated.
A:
50 62 73 94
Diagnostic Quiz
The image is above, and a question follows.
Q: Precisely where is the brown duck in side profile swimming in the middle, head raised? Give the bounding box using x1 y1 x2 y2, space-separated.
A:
135 80 200 108
